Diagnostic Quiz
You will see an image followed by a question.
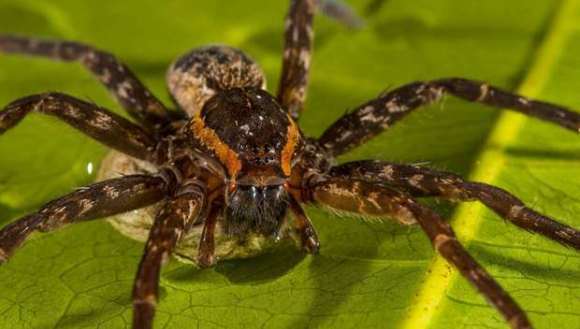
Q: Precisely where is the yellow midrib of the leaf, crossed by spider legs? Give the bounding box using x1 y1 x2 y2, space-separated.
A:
400 0 578 329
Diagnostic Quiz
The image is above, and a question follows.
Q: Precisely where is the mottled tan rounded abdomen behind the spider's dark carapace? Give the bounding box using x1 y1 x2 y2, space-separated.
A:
167 46 266 116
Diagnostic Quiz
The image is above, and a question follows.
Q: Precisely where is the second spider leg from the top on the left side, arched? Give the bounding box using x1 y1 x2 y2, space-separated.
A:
0 93 155 159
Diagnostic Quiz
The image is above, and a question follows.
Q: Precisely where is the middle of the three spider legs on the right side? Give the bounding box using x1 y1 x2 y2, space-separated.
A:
331 161 580 250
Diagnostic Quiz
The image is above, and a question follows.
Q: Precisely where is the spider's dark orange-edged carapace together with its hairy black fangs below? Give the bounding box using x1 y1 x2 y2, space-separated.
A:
190 88 300 237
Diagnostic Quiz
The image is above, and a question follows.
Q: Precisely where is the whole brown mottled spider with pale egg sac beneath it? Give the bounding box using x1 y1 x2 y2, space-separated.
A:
0 0 580 329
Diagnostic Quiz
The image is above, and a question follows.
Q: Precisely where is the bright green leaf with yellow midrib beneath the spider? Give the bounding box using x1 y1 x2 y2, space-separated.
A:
0 0 580 328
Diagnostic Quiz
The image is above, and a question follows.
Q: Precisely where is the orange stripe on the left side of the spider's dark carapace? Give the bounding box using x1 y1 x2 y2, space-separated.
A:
191 114 242 178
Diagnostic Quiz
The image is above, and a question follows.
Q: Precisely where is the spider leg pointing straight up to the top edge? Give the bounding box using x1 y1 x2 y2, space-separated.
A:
278 0 318 119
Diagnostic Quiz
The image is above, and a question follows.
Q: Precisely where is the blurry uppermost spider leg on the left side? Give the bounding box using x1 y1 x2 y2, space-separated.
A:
0 35 170 128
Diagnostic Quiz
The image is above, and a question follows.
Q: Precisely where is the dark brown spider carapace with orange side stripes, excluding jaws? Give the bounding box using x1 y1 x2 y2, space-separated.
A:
188 88 300 176
